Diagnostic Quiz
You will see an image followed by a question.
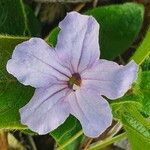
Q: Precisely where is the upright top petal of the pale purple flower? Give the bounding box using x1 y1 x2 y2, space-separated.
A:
56 12 100 73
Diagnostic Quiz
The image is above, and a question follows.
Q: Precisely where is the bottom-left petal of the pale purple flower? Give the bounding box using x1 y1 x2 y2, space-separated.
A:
20 85 69 134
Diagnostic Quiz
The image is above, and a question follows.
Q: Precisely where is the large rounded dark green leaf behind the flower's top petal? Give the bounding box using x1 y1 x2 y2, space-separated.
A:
47 3 144 59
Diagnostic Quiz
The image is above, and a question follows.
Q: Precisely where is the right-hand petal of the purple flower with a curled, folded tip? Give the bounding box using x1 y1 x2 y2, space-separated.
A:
81 60 138 99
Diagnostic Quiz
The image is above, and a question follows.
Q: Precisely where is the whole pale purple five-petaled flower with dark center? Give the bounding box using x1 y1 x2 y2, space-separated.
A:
7 12 138 137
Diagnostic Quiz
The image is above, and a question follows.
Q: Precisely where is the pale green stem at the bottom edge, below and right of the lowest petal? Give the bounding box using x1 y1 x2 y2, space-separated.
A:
89 132 126 150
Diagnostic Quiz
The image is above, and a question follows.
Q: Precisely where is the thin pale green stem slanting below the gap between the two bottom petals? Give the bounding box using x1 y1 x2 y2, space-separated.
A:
57 130 83 150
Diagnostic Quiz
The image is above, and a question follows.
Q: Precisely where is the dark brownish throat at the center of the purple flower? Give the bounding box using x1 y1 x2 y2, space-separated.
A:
68 73 81 91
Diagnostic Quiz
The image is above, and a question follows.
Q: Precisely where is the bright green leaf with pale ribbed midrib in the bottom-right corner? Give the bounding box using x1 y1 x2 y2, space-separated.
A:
122 106 150 150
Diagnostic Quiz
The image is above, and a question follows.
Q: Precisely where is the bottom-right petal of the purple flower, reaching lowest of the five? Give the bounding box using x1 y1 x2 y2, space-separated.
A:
68 88 112 137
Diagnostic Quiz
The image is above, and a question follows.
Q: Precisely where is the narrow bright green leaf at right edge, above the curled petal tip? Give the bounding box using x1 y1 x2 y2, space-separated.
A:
130 27 150 64
